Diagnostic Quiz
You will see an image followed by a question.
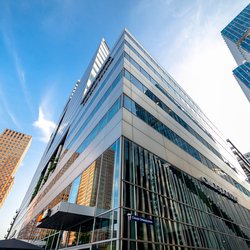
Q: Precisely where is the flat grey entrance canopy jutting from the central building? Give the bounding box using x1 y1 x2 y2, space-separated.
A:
37 201 95 230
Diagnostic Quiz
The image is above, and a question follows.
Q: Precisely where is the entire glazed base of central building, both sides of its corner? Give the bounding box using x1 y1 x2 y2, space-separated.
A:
20 138 250 250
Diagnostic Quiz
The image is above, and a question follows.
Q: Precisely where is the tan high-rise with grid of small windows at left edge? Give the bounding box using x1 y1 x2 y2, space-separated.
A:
0 129 31 207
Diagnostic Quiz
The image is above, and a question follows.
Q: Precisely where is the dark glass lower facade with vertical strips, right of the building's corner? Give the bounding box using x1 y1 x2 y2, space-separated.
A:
122 139 250 250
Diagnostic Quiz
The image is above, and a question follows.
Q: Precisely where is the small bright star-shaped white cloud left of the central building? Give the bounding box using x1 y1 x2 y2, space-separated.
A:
33 106 56 142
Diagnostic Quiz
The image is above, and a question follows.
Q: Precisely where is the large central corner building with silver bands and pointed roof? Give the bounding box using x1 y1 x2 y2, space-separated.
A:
10 30 250 250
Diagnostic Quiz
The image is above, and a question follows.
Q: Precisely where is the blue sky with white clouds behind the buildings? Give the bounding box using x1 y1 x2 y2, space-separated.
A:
0 0 250 238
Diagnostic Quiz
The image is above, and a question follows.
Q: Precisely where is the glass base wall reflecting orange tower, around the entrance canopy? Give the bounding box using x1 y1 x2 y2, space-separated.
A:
23 139 121 249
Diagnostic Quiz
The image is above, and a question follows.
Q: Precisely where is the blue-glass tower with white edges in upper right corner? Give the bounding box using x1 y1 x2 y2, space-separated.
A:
221 4 250 102
